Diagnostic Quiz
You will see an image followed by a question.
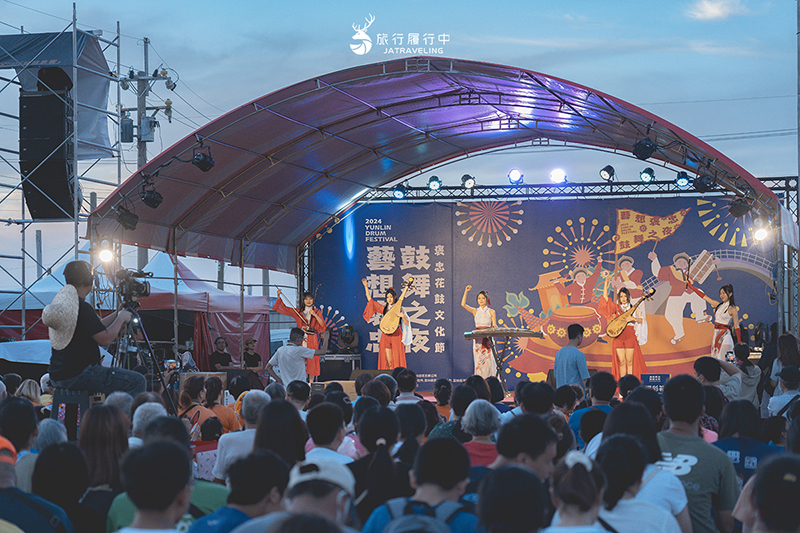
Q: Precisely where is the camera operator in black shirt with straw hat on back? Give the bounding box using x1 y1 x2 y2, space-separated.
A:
42 261 147 396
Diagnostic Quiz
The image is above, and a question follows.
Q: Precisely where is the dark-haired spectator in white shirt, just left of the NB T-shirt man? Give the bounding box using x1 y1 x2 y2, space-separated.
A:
597 434 681 533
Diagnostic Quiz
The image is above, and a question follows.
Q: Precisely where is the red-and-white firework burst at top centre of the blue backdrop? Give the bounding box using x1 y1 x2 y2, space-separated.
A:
455 201 524 248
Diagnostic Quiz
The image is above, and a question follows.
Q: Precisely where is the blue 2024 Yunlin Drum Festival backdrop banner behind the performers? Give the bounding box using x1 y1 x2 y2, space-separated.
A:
313 197 777 390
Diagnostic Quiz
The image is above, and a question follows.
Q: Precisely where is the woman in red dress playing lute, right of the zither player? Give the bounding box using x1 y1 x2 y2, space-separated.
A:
597 287 647 380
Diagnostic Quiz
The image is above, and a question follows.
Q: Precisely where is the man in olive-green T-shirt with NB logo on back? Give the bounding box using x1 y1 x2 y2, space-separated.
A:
656 374 739 533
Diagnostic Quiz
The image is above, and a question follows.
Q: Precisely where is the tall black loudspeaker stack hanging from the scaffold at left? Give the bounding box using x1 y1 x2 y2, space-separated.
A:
19 91 80 219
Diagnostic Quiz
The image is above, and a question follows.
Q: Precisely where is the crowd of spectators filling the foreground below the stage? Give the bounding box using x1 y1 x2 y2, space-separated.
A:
0 334 800 533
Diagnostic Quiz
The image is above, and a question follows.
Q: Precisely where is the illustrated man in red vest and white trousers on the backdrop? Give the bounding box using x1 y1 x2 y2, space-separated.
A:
647 252 708 344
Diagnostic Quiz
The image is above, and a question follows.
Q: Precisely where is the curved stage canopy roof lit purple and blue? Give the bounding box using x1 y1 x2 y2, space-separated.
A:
90 57 777 272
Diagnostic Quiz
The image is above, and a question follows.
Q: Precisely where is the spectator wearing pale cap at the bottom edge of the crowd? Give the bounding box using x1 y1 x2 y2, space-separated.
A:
233 461 356 533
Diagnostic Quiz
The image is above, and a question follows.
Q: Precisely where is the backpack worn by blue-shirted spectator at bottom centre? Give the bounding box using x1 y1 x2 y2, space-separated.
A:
384 498 468 533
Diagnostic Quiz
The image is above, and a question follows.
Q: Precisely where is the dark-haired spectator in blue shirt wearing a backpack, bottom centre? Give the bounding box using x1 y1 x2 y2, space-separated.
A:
362 436 478 533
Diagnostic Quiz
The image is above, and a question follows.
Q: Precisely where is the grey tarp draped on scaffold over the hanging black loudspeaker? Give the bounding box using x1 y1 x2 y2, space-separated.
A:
0 32 113 159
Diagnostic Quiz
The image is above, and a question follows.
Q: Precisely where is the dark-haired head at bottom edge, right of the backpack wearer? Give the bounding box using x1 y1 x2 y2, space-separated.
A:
477 466 549 533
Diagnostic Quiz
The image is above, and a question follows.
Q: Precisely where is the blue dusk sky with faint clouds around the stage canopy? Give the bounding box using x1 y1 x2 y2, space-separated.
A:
0 0 798 285
